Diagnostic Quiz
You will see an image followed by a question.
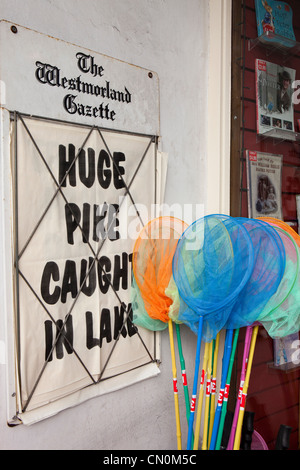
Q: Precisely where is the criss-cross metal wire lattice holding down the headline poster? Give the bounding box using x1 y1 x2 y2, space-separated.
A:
14 112 156 412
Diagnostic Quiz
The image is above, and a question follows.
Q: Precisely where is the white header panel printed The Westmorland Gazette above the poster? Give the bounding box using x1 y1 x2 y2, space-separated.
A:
0 20 159 135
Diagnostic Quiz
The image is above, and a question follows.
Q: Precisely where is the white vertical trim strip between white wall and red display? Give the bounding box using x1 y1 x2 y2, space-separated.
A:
205 0 232 214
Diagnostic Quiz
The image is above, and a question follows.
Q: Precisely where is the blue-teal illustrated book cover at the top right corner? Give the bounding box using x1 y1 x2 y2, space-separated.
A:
255 0 296 47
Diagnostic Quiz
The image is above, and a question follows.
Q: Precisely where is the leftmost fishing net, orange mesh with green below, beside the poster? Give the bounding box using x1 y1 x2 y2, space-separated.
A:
131 216 187 331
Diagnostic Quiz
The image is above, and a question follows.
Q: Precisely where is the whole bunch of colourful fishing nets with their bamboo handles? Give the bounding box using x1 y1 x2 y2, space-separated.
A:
131 214 300 450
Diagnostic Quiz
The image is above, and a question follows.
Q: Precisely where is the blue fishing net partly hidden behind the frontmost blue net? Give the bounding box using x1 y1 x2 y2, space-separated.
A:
226 217 285 329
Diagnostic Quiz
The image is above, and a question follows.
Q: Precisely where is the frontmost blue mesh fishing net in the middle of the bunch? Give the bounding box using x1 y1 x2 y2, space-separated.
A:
173 214 254 342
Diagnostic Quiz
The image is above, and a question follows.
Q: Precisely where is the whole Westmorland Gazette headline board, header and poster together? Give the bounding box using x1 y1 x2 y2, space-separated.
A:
0 21 161 424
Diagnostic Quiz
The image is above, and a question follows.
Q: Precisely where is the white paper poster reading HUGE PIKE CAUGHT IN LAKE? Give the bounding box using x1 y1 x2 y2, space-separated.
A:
11 116 158 414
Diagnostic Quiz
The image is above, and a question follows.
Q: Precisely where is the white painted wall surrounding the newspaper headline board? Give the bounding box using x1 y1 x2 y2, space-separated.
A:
0 0 227 450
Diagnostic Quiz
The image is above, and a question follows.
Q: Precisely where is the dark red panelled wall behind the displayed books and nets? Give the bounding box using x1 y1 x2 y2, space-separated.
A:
233 0 300 449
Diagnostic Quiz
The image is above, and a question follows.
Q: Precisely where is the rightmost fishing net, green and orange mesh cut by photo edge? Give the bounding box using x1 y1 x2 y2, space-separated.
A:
257 225 300 338
